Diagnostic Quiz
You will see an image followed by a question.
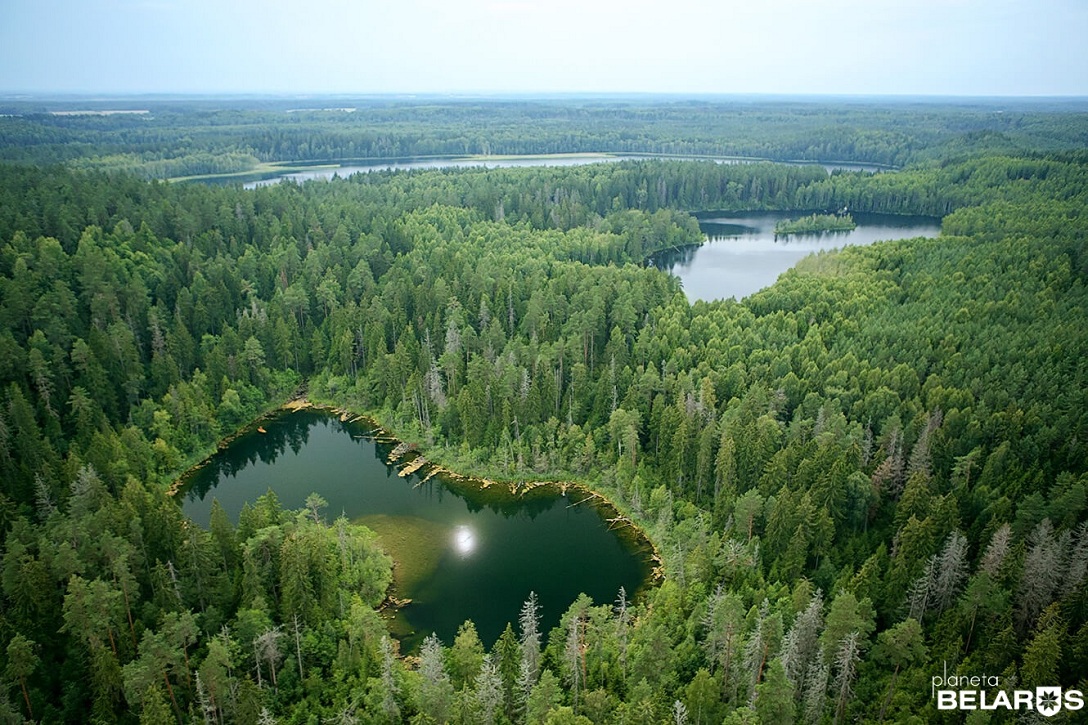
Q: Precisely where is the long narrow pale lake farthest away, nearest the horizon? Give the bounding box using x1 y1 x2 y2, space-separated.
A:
236 153 887 188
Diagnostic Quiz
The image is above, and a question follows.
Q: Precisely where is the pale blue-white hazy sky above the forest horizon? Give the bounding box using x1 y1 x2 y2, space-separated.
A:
0 0 1088 95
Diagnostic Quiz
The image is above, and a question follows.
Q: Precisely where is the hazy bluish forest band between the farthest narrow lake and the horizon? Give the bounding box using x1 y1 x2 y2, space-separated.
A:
6 96 1088 179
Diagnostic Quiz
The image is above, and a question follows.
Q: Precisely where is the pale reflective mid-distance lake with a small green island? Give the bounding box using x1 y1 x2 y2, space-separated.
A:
650 211 941 302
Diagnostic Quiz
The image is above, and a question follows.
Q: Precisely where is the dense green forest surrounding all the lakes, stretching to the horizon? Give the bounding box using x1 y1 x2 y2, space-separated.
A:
0 102 1088 725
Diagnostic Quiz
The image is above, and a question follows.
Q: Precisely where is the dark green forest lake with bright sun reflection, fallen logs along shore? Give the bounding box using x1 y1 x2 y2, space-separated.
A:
178 409 653 651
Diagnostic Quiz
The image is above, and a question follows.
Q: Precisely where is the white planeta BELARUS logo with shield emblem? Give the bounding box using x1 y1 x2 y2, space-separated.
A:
930 662 1085 717
